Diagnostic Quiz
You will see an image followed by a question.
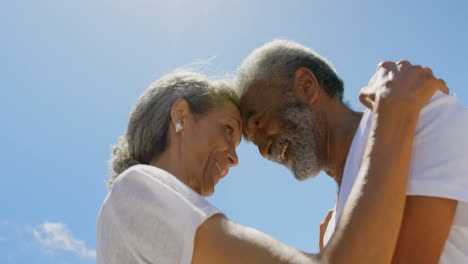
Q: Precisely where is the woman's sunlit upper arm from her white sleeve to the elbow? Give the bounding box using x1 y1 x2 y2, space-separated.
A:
192 215 318 264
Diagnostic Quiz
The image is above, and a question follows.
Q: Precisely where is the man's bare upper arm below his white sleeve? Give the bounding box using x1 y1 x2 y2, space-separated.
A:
393 196 457 264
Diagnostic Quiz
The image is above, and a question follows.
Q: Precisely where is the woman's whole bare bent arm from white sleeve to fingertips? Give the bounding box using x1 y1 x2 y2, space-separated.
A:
193 62 446 264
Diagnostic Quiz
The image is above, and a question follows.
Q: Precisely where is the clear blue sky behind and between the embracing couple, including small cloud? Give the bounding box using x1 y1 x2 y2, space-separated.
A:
0 0 468 263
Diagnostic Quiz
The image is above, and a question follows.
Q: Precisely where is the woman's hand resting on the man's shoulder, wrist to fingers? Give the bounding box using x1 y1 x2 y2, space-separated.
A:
359 60 449 113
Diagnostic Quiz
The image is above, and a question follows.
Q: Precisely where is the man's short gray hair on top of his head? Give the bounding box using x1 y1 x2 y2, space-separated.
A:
236 40 343 101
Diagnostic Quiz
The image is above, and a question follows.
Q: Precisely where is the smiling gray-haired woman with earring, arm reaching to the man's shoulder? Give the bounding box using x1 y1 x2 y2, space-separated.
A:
97 64 446 263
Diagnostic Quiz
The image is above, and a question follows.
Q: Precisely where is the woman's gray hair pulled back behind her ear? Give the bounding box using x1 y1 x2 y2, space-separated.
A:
108 70 239 189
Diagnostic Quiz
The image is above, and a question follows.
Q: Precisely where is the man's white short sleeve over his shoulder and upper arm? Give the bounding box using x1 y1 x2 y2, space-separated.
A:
407 92 468 202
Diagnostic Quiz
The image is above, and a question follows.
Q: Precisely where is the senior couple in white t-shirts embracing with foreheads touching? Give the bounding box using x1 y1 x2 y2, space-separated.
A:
97 40 468 264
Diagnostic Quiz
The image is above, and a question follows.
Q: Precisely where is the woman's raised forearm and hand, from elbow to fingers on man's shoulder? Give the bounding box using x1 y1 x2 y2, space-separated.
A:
321 61 448 263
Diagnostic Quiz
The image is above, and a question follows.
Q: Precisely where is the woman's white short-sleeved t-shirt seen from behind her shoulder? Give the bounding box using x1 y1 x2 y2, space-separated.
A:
96 165 220 264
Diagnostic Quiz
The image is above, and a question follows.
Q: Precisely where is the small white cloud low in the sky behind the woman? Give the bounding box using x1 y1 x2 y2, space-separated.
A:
32 222 96 258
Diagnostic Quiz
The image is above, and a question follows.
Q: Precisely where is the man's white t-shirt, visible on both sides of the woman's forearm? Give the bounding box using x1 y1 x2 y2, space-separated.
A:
324 92 468 264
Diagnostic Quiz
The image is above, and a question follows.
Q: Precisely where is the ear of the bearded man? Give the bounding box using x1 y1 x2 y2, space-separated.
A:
293 67 321 105
